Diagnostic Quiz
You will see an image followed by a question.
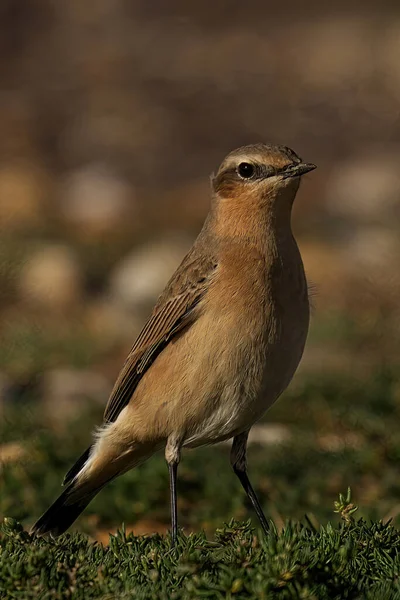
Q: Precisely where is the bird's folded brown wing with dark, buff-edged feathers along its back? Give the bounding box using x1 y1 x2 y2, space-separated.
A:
104 253 217 423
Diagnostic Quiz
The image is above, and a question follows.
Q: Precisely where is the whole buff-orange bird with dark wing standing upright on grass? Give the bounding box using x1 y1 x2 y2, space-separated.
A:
31 143 316 545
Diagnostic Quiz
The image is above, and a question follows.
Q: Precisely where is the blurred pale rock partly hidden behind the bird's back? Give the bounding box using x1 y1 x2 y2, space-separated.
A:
110 238 191 311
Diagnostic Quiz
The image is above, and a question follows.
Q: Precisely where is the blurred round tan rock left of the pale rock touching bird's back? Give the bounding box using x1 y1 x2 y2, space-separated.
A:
18 245 82 309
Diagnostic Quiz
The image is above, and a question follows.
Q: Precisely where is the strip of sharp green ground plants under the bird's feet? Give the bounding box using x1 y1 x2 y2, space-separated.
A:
0 519 400 600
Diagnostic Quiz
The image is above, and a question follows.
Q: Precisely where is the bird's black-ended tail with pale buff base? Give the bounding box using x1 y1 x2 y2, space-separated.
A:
31 424 159 537
